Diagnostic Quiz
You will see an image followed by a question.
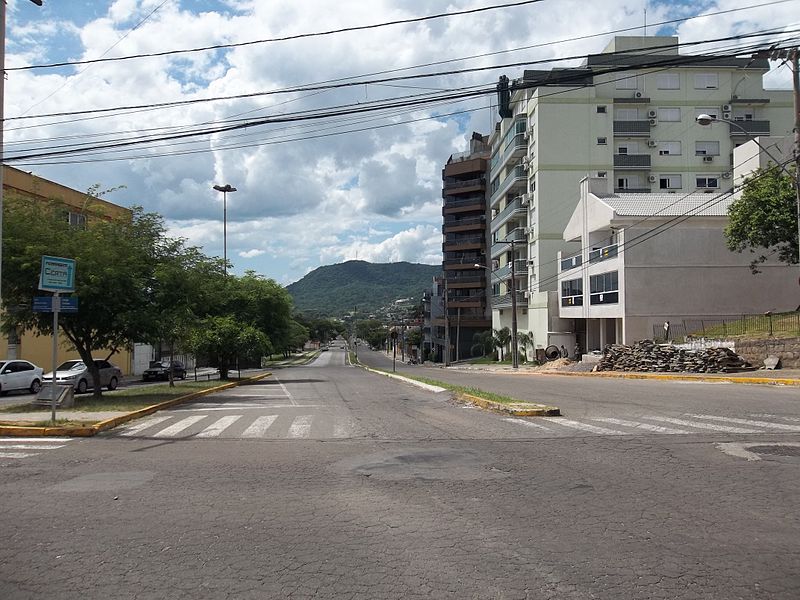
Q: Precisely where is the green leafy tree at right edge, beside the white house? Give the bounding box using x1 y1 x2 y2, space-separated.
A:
725 166 798 273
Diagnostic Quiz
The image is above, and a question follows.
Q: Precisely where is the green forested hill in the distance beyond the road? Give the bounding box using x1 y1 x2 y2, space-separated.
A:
286 260 442 317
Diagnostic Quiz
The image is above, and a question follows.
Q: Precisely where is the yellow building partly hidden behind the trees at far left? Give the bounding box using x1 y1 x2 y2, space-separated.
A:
0 166 133 375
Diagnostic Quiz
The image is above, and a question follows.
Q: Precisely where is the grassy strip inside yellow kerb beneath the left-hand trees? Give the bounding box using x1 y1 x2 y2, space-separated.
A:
0 379 238 412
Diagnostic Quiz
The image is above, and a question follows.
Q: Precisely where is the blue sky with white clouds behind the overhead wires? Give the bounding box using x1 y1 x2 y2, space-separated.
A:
4 0 800 285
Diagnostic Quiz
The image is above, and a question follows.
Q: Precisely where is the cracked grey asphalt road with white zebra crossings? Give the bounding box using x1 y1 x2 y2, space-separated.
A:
0 350 800 600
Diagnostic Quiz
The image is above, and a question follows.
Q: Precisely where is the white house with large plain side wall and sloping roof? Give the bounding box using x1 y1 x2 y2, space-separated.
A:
558 178 797 350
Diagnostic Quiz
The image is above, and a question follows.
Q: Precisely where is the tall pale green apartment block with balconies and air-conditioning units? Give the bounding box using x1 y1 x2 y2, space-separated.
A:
489 37 794 347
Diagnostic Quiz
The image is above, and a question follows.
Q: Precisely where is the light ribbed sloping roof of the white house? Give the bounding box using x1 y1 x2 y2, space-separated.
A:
597 193 733 217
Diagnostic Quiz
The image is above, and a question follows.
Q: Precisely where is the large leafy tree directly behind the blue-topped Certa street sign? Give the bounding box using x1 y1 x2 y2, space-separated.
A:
3 196 172 396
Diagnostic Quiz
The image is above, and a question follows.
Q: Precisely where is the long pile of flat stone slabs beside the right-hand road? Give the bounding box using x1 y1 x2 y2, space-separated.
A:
594 340 752 373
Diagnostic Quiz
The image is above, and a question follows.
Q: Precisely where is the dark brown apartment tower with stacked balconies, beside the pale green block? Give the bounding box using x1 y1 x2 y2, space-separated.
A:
431 133 492 361
